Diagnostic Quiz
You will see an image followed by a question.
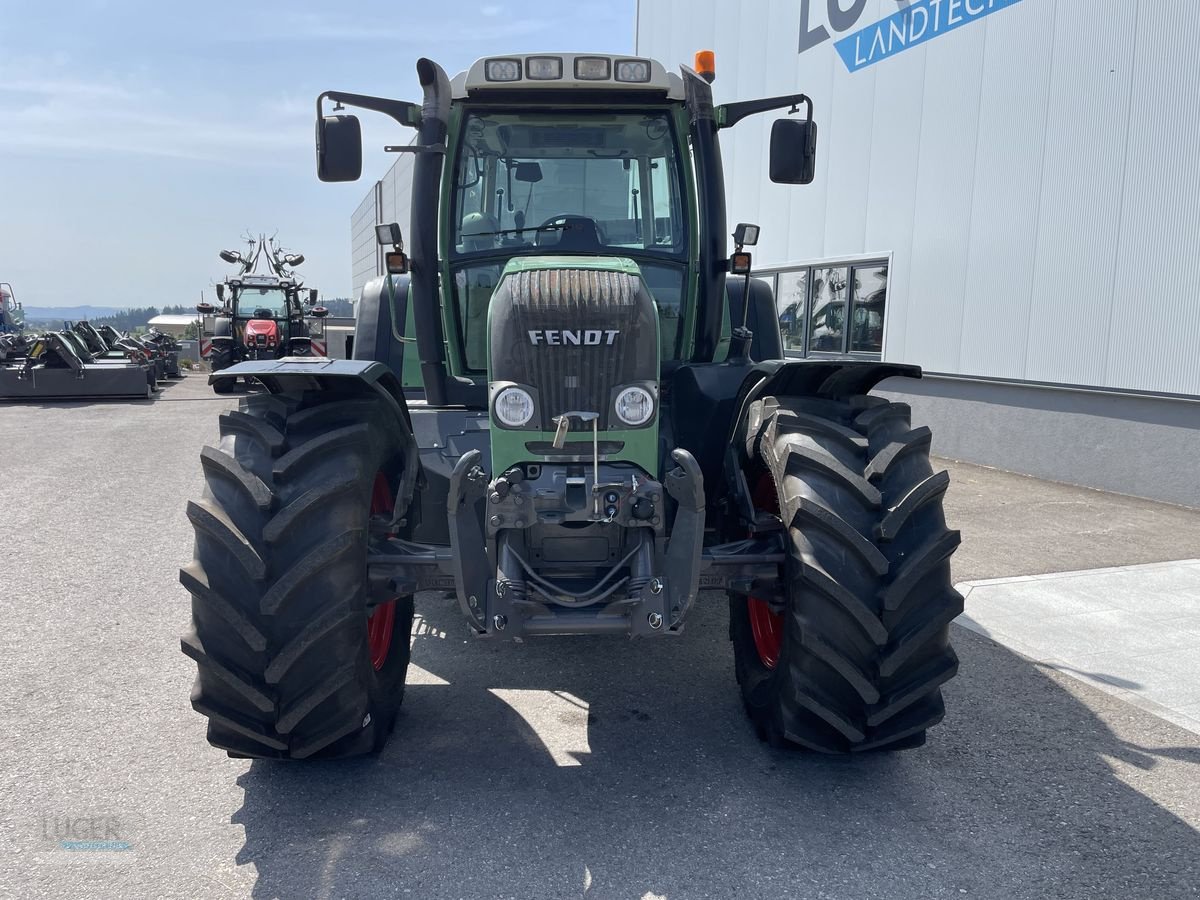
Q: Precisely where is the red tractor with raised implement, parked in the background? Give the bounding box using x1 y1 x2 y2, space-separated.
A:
196 235 329 394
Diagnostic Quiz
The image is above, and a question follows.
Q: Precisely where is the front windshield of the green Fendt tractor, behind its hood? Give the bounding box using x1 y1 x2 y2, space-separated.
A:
450 112 688 370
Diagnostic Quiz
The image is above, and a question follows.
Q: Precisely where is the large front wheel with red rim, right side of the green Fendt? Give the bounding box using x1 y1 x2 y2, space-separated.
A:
730 397 962 754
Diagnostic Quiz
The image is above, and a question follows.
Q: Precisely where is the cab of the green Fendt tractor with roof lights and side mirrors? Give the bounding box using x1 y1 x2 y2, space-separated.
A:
318 53 816 407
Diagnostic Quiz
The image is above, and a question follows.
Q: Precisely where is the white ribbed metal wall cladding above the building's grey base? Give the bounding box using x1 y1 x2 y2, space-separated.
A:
637 0 1200 394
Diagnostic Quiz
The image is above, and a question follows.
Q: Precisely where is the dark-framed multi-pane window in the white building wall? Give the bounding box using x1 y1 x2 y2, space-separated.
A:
757 259 888 356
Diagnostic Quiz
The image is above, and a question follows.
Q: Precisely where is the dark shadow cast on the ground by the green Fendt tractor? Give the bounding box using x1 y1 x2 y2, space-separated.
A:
234 594 1200 900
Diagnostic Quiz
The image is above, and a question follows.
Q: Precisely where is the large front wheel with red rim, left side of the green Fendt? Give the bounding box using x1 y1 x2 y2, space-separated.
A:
180 392 413 758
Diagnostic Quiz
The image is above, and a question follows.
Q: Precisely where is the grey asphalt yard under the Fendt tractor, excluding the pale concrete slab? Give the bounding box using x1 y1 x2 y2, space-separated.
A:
0 377 1200 900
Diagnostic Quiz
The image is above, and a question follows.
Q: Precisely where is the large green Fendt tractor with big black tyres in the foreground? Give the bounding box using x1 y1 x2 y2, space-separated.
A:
181 53 962 758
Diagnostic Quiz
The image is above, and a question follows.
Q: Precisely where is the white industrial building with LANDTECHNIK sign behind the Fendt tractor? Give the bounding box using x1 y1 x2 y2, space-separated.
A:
354 0 1200 505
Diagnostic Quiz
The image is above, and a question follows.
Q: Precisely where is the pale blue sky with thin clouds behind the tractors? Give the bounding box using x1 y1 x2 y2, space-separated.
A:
0 0 635 306
